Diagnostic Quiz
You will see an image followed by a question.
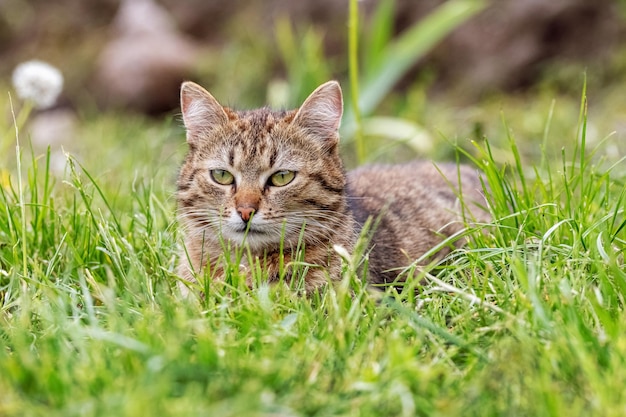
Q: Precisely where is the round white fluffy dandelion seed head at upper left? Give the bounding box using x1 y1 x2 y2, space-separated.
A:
13 60 63 109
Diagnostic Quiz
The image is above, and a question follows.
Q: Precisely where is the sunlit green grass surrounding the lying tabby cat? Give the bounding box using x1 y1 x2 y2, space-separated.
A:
0 79 626 416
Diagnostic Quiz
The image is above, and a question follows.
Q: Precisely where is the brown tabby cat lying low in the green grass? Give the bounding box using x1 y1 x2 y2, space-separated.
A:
177 81 486 294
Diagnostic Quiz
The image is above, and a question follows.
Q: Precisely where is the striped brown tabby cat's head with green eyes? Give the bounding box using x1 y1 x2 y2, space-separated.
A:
178 81 346 252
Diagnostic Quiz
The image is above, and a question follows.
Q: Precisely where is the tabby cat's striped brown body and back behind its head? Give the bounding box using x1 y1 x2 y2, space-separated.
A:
347 161 489 283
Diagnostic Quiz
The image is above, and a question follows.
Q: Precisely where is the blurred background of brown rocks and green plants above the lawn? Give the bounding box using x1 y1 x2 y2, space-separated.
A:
0 0 626 171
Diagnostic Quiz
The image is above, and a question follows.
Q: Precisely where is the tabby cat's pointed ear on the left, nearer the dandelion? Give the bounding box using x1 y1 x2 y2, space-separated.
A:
180 81 228 143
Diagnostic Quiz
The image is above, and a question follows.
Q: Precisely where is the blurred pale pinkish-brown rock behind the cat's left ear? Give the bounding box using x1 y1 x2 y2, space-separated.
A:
96 0 200 113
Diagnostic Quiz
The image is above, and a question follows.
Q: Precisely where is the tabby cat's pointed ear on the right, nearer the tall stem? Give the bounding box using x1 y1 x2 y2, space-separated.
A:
293 81 343 145
